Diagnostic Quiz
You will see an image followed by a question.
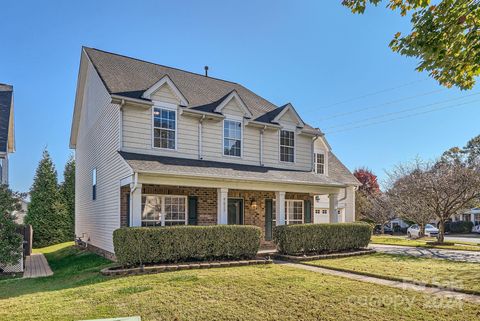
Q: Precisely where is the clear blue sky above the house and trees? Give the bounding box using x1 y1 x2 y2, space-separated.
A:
0 0 480 191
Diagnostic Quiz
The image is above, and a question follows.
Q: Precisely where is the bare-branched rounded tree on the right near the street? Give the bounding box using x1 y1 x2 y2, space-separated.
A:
389 160 480 243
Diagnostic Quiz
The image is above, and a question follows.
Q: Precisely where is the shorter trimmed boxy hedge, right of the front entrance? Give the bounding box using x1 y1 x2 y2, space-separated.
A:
274 223 372 255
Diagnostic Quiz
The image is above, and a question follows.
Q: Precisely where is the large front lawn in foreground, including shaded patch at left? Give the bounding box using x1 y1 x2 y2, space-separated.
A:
0 245 480 321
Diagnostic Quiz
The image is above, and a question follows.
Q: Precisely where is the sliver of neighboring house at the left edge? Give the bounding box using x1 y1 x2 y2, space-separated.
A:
0 84 15 185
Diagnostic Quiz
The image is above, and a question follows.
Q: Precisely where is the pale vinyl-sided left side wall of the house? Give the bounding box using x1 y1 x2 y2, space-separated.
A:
75 57 131 252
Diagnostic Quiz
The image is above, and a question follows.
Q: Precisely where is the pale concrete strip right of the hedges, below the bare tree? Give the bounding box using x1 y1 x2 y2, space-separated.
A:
368 244 480 263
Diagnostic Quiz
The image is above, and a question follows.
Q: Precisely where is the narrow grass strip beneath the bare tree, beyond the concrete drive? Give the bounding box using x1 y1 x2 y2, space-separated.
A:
370 235 480 251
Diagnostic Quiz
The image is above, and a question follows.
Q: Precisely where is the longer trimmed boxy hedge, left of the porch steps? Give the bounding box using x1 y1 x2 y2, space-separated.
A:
113 225 261 265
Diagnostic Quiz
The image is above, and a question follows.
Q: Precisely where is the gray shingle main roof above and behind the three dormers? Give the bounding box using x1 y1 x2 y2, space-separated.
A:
84 47 320 130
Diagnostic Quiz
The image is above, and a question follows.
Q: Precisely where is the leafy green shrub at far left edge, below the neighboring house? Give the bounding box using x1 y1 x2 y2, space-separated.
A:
0 185 22 266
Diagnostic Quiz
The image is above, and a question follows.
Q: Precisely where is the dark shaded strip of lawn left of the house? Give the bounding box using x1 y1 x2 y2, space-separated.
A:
0 244 112 300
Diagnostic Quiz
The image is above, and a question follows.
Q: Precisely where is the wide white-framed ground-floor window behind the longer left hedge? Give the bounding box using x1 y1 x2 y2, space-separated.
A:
142 195 188 226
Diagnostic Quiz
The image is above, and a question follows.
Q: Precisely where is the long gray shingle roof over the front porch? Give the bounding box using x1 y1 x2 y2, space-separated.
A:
119 152 359 186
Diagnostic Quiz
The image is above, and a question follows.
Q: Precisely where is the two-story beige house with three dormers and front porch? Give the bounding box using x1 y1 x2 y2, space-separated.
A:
70 48 359 255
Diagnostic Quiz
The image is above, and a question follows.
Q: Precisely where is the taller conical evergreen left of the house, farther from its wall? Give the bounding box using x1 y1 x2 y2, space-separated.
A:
25 149 67 247
